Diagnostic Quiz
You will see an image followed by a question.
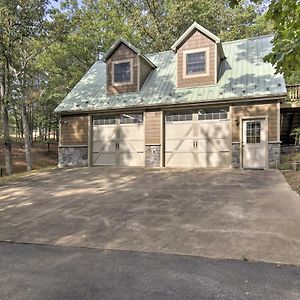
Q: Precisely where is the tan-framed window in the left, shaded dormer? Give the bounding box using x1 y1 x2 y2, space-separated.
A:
112 59 133 85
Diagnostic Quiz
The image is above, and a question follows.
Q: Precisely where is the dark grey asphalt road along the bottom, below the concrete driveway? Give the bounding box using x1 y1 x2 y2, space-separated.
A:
0 242 300 300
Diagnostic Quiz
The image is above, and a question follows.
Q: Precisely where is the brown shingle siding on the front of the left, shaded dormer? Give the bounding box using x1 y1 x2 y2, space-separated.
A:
106 44 138 94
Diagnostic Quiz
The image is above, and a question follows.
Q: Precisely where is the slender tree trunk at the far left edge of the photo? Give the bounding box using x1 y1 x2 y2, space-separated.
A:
0 64 13 175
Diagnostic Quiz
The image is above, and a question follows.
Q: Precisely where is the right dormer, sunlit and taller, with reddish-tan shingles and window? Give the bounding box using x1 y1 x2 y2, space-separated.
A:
171 22 225 88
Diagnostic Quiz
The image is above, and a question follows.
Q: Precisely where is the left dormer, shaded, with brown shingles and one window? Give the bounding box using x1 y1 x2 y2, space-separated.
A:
103 39 156 95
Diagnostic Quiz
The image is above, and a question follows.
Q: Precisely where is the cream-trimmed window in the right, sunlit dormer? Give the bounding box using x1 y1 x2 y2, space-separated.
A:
183 48 209 78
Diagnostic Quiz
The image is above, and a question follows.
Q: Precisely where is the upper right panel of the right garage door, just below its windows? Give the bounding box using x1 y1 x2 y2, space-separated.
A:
198 121 229 139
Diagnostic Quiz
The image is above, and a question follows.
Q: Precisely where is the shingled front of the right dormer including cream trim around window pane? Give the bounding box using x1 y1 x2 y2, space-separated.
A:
176 30 218 88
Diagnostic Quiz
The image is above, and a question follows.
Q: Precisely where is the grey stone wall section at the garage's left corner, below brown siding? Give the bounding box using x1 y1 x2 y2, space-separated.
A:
58 146 88 167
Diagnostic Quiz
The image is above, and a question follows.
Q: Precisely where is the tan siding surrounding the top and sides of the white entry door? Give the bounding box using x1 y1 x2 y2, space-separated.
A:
232 103 279 142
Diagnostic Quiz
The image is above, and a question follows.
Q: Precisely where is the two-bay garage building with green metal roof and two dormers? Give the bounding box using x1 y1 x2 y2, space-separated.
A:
55 23 286 169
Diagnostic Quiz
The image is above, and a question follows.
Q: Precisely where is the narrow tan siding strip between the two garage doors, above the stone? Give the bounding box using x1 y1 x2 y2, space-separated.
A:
145 111 161 145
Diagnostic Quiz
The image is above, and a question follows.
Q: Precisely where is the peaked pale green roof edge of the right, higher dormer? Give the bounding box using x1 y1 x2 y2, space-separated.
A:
171 22 225 59
